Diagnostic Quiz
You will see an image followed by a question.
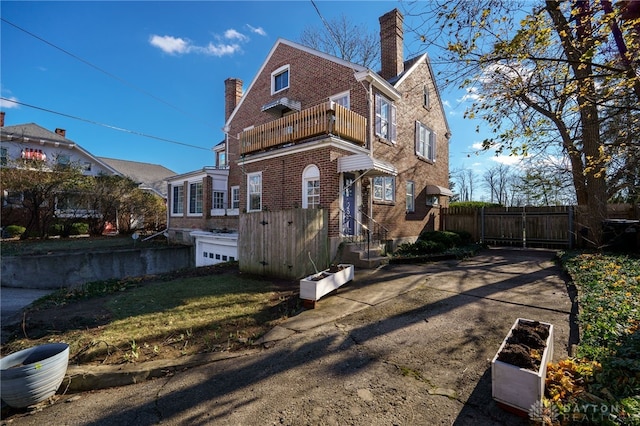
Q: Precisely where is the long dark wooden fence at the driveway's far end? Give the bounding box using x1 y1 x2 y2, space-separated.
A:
441 204 637 248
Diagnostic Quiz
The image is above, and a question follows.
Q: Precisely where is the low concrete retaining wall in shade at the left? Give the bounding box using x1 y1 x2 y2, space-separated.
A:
1 246 194 289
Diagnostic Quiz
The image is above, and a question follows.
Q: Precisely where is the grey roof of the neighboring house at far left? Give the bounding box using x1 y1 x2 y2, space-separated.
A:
0 123 120 175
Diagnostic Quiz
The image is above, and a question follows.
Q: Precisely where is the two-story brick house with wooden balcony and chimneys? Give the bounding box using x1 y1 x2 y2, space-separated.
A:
169 9 452 266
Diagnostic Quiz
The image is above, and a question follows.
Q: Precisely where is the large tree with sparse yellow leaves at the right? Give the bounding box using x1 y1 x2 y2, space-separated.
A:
405 0 640 246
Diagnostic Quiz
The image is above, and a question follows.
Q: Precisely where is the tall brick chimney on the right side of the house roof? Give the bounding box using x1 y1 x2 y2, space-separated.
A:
379 9 404 80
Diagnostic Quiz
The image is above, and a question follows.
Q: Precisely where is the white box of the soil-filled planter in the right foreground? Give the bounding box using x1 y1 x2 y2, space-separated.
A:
491 318 553 415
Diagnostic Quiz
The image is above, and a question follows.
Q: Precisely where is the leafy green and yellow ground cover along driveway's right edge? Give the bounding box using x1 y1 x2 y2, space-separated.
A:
547 253 640 425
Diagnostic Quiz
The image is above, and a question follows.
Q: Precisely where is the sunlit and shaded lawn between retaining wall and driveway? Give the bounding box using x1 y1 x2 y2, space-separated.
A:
2 264 300 364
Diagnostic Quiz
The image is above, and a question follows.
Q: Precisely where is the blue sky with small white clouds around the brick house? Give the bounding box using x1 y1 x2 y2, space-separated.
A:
0 0 508 180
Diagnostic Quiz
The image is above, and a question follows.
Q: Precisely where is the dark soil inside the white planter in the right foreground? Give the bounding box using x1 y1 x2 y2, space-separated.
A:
498 320 549 371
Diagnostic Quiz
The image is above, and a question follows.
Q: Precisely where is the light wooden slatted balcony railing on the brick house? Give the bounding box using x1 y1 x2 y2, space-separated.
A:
240 102 367 155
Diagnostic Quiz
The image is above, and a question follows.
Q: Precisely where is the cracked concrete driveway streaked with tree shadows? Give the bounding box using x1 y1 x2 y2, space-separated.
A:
1 250 574 426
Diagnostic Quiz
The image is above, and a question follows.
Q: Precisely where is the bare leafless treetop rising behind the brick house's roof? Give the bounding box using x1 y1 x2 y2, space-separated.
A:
300 15 380 68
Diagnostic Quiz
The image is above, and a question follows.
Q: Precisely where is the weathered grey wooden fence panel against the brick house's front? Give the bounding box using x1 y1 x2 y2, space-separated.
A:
238 209 329 280
